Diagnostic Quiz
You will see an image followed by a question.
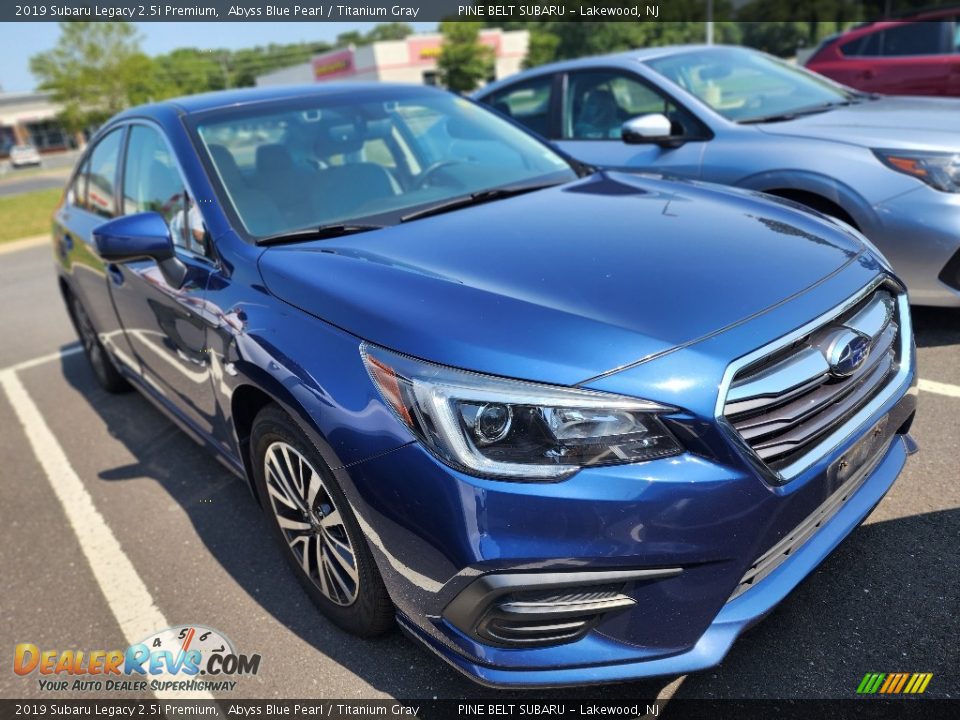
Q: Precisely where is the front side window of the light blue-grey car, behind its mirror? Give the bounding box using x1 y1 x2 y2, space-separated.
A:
563 71 690 140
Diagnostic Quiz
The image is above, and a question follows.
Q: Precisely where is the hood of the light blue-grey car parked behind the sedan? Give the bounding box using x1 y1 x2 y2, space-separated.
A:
757 96 960 151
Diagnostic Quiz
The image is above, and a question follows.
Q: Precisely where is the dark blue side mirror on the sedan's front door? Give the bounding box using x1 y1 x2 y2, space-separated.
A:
93 212 187 289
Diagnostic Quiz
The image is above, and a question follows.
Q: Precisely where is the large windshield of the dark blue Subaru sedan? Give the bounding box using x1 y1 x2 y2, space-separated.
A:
195 88 576 238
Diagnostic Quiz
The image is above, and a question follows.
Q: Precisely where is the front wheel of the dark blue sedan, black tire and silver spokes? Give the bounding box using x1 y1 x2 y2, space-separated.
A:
250 405 395 637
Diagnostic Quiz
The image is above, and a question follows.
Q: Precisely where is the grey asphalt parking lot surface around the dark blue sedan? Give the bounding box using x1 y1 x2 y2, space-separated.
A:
0 239 960 699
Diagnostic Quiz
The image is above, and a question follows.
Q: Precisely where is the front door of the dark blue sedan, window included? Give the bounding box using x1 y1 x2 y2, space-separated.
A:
107 123 216 437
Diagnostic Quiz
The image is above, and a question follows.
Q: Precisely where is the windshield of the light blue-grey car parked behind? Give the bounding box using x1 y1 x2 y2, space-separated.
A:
647 48 856 122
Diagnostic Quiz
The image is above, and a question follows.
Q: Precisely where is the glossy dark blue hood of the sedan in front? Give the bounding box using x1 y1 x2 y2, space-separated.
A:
260 173 862 385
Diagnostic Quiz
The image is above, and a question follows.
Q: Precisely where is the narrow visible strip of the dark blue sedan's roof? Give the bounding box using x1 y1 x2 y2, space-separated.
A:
116 82 445 119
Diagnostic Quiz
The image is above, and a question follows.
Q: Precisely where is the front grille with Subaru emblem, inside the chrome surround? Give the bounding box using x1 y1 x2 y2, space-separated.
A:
723 286 903 479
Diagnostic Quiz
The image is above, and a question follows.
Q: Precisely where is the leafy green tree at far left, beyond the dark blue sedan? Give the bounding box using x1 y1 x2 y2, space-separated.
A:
30 22 156 132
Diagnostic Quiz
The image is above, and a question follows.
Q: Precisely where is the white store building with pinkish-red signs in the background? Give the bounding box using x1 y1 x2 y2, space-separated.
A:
257 28 530 87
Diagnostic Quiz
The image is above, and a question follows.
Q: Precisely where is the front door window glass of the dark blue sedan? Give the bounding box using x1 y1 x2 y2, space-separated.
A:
123 125 208 255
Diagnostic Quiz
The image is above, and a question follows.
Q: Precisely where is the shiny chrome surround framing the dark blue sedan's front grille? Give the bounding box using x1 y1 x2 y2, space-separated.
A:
714 275 913 486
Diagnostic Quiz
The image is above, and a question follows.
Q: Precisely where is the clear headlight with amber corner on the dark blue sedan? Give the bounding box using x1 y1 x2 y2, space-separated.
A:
360 343 681 480
